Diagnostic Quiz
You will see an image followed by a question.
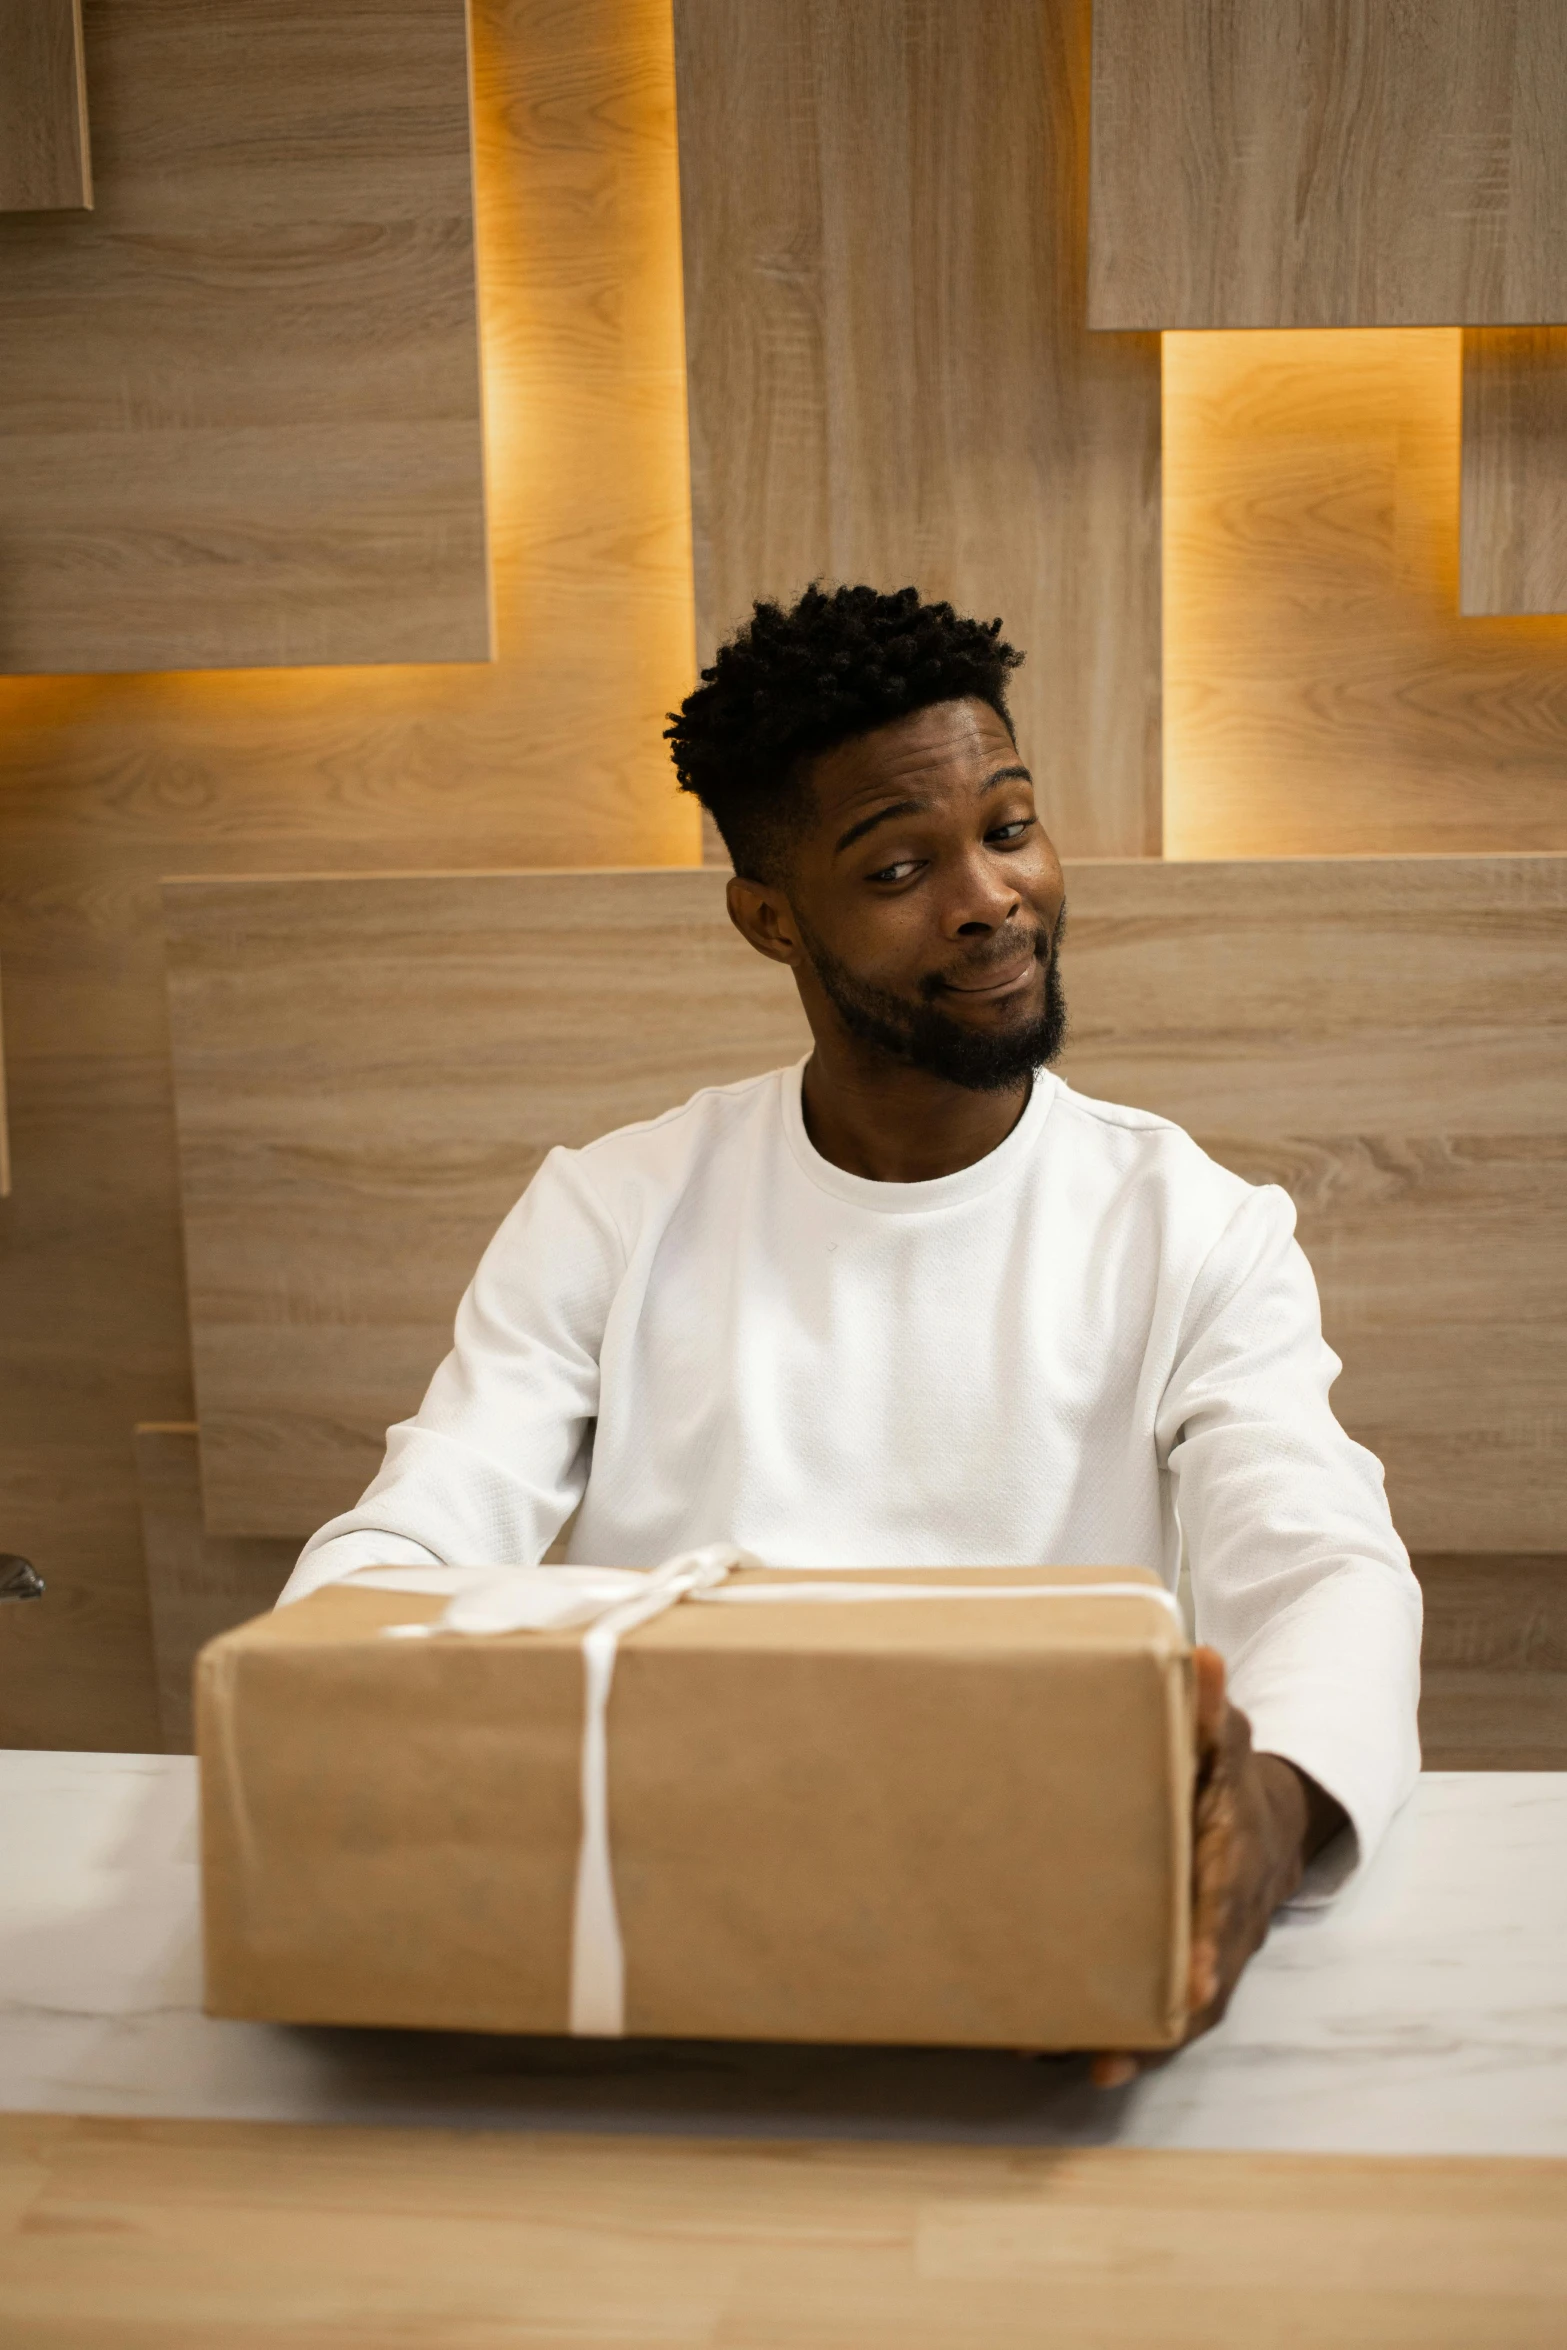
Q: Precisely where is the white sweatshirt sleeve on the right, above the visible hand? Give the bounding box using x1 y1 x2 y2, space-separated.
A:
1158 1187 1421 1899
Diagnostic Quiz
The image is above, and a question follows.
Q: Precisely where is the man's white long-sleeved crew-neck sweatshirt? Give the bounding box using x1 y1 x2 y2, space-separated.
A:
284 1062 1421 1889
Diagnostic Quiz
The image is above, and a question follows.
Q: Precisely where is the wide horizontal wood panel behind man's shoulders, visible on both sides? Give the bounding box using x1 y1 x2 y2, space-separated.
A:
167 858 1567 1551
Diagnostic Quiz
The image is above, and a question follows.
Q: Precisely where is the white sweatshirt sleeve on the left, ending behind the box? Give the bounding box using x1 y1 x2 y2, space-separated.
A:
282 1152 625 1600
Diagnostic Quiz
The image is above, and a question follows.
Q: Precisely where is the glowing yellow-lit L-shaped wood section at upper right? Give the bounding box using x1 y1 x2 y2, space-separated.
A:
1165 336 1567 858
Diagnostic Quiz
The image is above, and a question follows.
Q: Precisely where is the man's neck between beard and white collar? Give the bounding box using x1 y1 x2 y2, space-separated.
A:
801 1036 1031 1182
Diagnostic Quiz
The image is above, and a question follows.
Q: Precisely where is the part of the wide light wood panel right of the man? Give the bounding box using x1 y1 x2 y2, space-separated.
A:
1064 858 1567 1551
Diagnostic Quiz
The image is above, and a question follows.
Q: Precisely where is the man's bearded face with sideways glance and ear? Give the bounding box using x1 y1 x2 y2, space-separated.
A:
731 700 1064 1090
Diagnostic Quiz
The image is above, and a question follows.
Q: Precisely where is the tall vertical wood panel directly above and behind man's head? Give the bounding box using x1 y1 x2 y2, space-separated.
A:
674 0 1158 855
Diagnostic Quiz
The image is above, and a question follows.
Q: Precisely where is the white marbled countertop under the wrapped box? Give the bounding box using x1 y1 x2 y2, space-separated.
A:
0 1753 1567 2155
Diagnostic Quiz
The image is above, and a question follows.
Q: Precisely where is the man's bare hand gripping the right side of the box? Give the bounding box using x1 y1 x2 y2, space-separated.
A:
1092 1647 1346 2089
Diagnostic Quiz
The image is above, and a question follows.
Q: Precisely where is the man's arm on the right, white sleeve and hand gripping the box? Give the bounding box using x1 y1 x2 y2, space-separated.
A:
1095 1187 1421 2087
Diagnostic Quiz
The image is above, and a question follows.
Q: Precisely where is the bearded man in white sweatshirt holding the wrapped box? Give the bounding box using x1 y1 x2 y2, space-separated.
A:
287 588 1419 2082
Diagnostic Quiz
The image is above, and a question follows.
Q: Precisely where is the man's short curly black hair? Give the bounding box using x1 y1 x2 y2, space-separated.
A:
665 585 1022 881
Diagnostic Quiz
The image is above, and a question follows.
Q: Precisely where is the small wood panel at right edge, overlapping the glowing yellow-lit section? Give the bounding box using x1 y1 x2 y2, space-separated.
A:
1459 327 1567 613
